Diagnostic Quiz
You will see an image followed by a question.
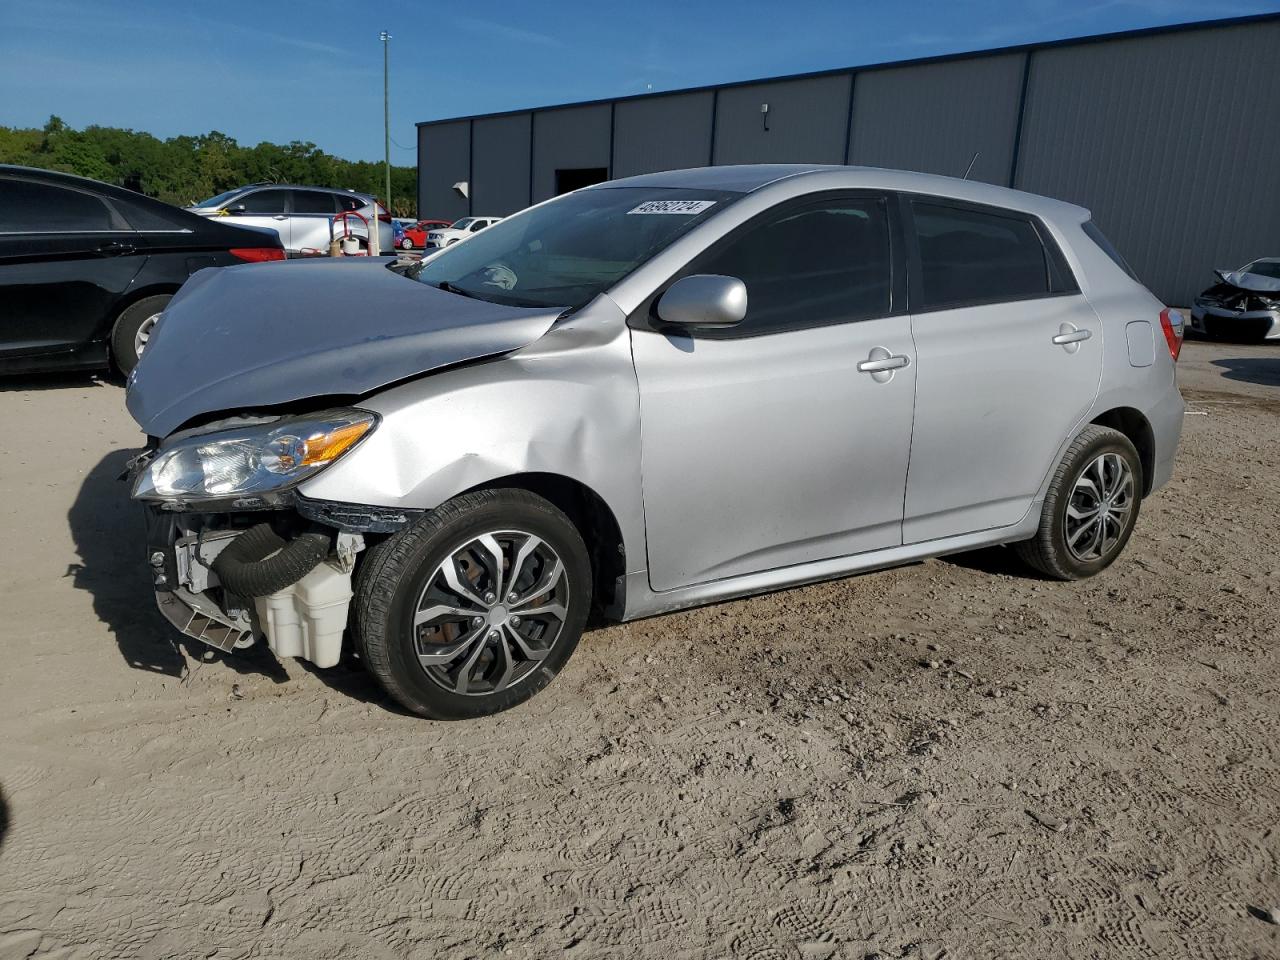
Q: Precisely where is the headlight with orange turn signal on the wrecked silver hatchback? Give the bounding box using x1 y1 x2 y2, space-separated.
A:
133 410 378 509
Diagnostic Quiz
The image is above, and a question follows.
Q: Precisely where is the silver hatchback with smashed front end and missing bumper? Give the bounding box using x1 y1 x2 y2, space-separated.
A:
128 166 1183 718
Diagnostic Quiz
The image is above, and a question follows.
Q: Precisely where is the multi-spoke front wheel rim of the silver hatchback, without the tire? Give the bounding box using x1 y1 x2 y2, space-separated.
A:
412 530 570 696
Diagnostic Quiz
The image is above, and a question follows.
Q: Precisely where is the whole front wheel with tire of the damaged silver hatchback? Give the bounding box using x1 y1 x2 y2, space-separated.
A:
355 489 591 719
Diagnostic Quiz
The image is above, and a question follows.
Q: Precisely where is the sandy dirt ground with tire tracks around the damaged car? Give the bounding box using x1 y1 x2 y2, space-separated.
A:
0 343 1280 960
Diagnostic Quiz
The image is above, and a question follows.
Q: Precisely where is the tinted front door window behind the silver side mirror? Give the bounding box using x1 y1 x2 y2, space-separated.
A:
691 198 892 337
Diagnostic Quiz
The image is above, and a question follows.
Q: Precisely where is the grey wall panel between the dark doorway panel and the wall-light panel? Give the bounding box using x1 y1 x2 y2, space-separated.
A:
613 90 716 178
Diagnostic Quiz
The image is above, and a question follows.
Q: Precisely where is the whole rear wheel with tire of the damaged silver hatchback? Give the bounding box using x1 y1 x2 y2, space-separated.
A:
1015 425 1143 580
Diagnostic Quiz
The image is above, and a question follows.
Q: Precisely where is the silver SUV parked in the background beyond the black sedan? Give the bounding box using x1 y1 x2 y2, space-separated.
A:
187 183 396 256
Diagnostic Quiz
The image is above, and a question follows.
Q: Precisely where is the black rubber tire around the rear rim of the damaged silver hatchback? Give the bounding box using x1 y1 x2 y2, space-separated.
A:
1014 425 1143 580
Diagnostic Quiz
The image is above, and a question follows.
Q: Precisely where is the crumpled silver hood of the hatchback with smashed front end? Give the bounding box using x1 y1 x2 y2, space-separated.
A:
125 257 562 436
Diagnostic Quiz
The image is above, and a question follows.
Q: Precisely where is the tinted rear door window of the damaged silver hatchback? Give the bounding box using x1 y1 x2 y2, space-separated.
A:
911 202 1052 310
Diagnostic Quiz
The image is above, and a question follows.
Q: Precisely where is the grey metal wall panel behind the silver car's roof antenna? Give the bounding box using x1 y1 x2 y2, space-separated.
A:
849 52 1027 186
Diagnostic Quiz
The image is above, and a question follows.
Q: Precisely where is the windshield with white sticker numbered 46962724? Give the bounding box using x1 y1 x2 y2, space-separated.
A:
410 187 739 307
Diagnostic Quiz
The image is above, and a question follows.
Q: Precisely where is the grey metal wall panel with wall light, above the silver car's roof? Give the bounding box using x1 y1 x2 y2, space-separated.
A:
716 74 849 164
